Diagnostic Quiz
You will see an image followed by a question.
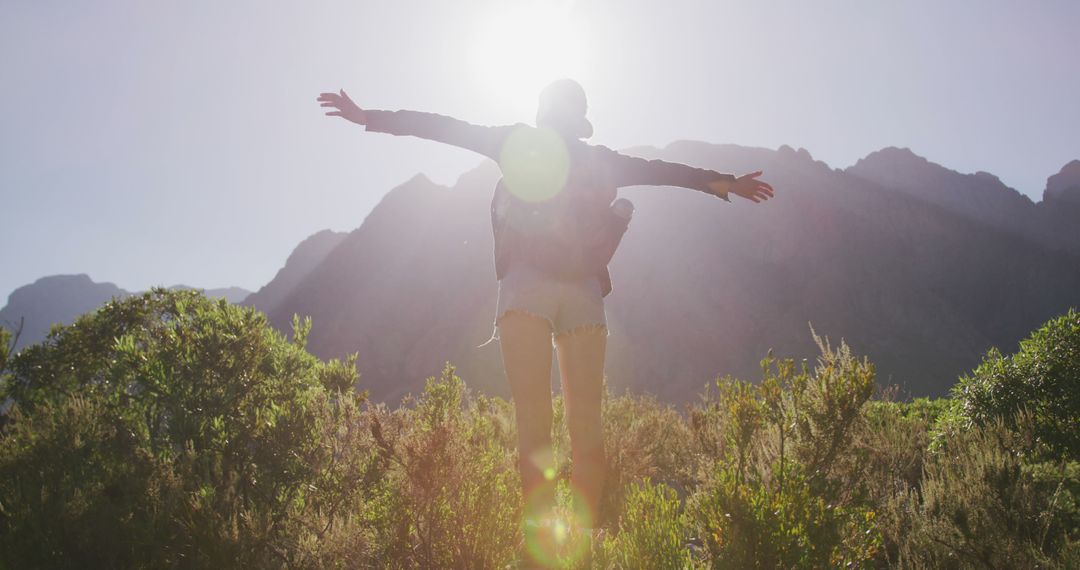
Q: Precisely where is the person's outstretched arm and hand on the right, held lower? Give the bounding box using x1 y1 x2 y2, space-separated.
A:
597 147 773 202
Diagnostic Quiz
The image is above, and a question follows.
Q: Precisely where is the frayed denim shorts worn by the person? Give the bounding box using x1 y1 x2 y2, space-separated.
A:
495 263 607 336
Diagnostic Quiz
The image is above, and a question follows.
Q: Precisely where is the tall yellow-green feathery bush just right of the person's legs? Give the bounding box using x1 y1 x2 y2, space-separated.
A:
687 337 880 568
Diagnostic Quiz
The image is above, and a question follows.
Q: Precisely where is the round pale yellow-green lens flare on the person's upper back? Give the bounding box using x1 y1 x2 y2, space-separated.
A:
499 126 570 202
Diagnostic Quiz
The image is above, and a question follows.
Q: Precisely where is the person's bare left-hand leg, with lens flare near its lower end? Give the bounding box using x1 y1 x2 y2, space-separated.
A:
499 311 555 519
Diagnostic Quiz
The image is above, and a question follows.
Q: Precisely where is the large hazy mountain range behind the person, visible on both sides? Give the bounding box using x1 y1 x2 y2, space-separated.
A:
248 143 1080 402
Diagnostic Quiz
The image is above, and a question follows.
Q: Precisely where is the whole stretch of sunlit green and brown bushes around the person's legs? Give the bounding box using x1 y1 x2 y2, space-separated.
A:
0 289 1080 569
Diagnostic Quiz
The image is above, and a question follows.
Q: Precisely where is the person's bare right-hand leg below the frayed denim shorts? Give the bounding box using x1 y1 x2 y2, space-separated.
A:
555 326 607 526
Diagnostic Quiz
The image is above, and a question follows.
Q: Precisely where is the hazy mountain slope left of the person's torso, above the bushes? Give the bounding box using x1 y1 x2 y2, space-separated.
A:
248 167 502 399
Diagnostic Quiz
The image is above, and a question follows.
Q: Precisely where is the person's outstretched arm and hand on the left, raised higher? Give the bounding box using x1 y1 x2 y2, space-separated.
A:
319 90 513 160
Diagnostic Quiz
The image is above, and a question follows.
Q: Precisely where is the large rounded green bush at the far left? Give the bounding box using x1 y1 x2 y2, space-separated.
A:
0 289 368 568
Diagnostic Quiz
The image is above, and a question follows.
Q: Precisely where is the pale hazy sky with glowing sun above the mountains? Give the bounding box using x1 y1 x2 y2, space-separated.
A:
0 0 1080 306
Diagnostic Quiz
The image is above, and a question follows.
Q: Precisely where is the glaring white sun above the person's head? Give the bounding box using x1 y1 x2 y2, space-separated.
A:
472 0 588 109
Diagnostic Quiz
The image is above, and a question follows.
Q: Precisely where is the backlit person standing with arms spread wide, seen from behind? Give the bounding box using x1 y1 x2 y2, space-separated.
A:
319 80 773 561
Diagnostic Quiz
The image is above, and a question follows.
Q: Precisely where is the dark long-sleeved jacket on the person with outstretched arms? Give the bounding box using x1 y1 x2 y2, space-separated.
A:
365 110 734 296
